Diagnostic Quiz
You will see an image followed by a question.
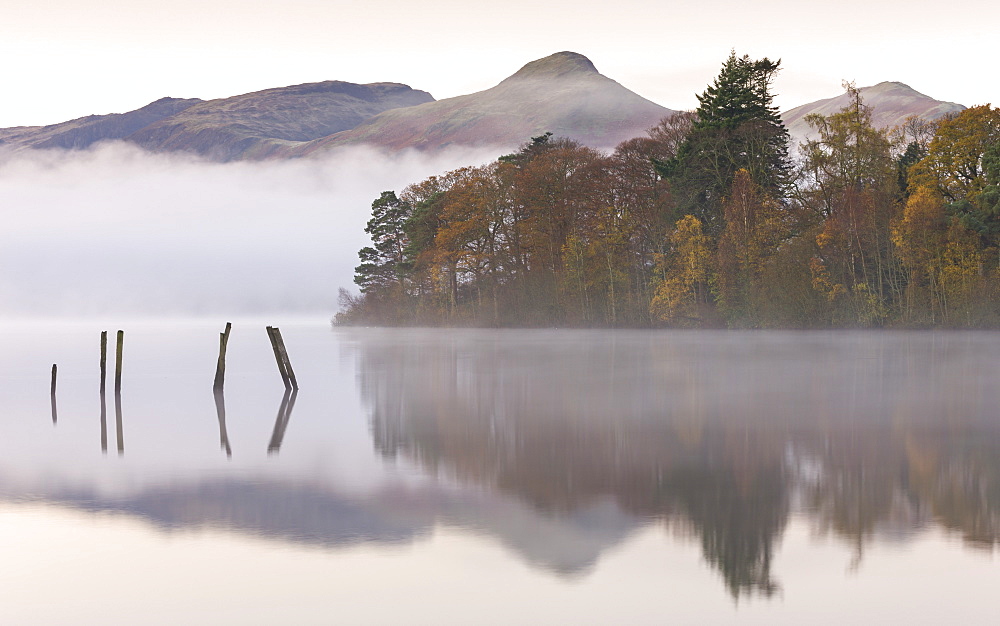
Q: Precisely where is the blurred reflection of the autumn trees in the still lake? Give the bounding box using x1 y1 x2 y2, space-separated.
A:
351 330 1000 596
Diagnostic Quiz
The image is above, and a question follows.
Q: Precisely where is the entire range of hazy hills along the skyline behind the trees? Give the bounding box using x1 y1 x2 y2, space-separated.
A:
0 51 965 162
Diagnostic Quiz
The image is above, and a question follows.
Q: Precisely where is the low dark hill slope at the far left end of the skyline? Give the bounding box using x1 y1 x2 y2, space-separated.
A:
0 98 202 150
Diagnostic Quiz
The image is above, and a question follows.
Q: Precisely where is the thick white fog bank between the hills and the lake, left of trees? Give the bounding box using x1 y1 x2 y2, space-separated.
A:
0 143 503 318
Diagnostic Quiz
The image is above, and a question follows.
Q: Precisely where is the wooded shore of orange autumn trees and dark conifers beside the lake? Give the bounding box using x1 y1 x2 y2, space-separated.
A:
337 54 1000 328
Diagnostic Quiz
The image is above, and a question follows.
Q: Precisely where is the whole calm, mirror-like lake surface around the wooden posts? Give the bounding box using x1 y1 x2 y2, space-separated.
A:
0 320 1000 624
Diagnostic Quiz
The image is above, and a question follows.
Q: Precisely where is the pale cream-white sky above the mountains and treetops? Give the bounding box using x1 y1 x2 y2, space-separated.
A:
0 0 1000 127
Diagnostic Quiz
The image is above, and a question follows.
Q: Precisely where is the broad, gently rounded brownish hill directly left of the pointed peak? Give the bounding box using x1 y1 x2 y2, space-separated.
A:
128 80 434 161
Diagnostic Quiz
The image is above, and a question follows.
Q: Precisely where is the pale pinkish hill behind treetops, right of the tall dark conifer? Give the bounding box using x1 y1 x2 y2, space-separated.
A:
781 82 965 145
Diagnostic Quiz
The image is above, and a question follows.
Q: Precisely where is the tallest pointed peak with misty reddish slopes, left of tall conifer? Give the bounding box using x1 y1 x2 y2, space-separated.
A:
288 52 673 156
